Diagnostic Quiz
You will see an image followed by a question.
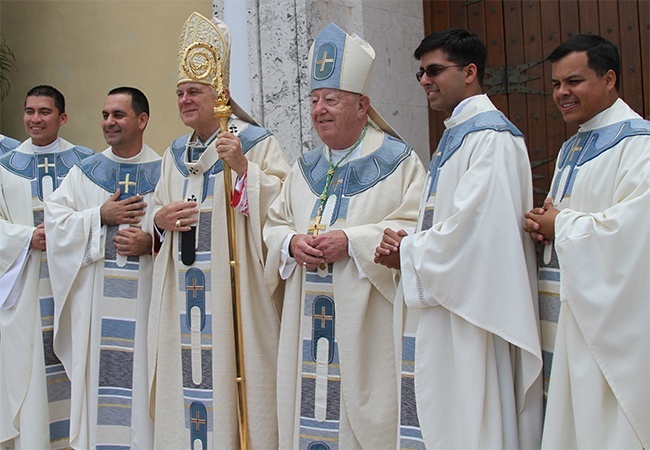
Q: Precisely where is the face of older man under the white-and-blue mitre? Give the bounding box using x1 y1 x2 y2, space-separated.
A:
311 89 370 150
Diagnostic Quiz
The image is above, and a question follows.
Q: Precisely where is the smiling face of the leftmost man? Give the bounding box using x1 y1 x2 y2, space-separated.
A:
23 95 68 147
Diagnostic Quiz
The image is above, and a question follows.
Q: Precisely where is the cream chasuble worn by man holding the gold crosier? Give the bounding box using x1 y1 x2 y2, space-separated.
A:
149 119 289 449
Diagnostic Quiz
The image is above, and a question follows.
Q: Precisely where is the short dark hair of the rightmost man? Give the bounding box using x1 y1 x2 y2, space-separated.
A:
546 34 621 92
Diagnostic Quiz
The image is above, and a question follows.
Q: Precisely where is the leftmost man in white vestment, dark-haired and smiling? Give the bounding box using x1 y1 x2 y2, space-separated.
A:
0 86 93 449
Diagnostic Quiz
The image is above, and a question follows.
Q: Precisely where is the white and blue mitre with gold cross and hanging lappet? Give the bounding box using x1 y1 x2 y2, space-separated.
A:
309 23 401 139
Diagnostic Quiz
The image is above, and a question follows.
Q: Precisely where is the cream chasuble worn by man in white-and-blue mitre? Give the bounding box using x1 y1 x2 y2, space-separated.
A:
264 128 424 449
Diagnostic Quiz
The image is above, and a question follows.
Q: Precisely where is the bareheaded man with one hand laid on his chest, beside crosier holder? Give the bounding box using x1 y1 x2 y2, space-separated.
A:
45 87 160 449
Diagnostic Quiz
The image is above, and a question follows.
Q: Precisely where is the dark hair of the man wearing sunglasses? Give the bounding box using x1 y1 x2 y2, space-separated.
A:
413 28 487 84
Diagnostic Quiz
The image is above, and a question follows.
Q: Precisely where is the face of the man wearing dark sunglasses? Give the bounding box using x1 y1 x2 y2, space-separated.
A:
420 48 470 116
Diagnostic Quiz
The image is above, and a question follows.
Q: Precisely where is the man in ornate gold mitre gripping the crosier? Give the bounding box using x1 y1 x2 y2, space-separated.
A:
149 13 289 449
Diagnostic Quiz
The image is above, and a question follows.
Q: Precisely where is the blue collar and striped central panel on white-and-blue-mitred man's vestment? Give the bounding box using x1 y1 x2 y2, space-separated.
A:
296 135 412 450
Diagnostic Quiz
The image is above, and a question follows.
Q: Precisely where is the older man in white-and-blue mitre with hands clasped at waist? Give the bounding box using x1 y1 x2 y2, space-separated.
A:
264 23 424 449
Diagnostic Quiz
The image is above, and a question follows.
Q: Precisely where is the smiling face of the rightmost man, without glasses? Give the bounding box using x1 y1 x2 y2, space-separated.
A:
551 52 618 125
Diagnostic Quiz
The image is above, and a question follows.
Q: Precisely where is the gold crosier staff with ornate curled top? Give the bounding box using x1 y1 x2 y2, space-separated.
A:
183 43 248 450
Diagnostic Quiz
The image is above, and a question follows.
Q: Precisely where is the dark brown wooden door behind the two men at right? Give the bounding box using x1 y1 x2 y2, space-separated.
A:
423 0 650 205
